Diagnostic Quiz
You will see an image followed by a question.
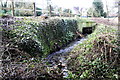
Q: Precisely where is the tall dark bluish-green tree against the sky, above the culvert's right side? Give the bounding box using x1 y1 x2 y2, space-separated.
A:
93 0 104 17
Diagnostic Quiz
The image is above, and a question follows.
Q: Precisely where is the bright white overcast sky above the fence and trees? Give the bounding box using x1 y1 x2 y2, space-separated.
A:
35 0 114 8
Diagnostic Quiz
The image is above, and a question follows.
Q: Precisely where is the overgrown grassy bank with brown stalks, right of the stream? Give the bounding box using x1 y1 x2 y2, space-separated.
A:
68 25 118 80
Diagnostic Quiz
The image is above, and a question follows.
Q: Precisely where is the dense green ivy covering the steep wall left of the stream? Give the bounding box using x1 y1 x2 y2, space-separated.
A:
8 18 78 56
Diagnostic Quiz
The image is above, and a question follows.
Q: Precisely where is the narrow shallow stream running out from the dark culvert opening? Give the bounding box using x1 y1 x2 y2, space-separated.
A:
46 38 86 77
